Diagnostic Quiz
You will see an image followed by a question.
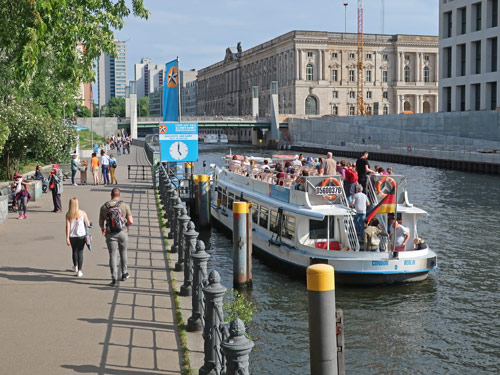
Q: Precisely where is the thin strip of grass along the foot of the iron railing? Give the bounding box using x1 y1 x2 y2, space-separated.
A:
155 189 195 375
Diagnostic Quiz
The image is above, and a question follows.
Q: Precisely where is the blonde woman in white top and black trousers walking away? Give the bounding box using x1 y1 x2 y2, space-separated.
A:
66 198 90 277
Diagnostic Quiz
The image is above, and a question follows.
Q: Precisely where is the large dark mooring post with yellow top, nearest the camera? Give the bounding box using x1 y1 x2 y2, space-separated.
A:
307 264 338 375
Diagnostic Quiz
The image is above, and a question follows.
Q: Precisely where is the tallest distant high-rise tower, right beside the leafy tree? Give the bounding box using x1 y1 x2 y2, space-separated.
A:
97 40 127 107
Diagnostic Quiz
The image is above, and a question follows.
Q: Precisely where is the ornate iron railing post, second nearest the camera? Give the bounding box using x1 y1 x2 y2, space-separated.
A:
199 271 226 375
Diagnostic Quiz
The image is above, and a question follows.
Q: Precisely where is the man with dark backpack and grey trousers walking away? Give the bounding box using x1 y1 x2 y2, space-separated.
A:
99 188 134 286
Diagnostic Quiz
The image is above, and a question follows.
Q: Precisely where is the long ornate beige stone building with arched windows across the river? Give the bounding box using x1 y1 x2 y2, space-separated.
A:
197 31 438 116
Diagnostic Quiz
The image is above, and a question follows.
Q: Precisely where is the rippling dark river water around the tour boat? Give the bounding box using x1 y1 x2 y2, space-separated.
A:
195 145 500 375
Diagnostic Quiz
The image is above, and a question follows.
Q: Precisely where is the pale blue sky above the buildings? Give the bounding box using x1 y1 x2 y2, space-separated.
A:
115 0 439 81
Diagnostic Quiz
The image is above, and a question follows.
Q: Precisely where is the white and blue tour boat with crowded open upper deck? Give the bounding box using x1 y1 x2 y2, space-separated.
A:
211 157 437 285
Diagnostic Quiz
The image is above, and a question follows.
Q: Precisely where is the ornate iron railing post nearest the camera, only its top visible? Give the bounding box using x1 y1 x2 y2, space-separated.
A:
221 318 254 375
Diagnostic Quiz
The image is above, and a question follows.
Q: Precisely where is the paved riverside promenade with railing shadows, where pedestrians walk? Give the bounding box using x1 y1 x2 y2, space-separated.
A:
0 147 181 375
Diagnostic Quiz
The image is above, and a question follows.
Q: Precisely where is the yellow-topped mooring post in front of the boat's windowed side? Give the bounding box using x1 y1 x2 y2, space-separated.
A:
233 202 252 288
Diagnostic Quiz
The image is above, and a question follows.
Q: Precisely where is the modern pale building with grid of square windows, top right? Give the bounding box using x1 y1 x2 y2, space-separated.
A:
439 0 500 112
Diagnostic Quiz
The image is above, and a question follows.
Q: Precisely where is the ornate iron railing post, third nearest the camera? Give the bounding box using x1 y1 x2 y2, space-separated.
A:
187 240 210 332
